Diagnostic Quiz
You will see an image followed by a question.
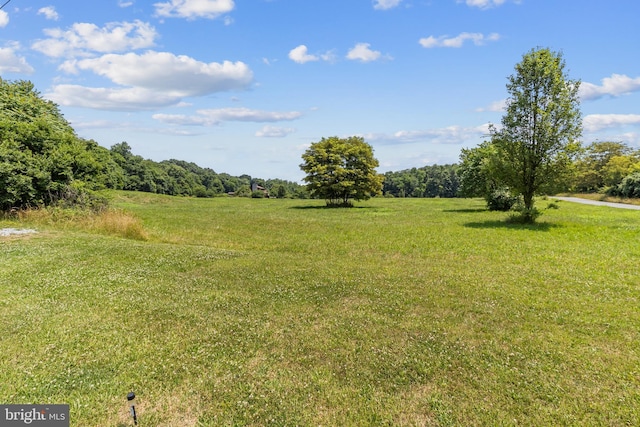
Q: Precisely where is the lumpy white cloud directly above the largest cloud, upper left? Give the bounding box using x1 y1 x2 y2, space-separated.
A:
31 21 158 58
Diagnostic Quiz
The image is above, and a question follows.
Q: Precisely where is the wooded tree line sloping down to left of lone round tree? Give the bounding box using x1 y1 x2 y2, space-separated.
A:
0 78 308 211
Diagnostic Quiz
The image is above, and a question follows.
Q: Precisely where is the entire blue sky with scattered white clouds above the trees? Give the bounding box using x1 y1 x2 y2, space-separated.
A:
0 0 640 181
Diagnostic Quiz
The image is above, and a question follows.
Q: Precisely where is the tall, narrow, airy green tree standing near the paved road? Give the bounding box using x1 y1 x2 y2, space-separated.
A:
491 48 582 221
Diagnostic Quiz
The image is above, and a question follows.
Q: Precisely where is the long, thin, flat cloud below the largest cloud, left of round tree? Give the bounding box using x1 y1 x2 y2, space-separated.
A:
153 108 302 126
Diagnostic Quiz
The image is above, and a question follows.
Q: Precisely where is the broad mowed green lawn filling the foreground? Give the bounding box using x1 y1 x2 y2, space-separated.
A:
0 192 640 426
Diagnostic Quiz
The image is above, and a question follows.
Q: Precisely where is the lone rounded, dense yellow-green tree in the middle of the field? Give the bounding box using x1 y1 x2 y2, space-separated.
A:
300 136 384 206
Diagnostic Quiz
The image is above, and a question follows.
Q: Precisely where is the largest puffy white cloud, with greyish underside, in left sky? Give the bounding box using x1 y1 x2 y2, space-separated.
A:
63 51 253 97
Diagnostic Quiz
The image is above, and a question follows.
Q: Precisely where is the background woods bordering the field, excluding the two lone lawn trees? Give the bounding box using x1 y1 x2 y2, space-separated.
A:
0 78 640 211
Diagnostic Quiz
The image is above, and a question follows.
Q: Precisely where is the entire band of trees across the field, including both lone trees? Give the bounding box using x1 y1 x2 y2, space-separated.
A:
0 49 640 216
